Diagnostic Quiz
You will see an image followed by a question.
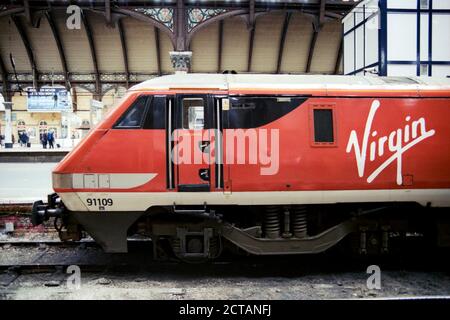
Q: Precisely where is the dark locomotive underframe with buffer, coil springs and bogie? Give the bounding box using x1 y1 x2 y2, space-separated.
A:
33 194 450 262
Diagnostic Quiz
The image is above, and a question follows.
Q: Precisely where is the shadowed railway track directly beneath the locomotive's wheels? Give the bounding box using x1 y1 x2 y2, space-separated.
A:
0 238 448 272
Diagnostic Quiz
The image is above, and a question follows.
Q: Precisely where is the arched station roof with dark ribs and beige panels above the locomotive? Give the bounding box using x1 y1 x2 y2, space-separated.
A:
0 0 355 99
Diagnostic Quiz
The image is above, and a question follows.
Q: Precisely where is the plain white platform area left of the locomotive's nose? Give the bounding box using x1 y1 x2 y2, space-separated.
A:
0 162 57 204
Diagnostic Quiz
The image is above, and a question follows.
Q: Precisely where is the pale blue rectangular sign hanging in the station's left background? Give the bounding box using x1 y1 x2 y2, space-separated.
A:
27 87 72 112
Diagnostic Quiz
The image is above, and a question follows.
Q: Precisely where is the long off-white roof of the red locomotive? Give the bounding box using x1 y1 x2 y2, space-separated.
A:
130 73 450 95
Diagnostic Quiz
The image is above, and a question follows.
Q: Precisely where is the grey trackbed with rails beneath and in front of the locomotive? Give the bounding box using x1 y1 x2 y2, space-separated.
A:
0 239 450 300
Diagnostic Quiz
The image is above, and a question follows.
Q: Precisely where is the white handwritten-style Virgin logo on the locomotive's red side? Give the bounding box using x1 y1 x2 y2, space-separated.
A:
346 100 435 185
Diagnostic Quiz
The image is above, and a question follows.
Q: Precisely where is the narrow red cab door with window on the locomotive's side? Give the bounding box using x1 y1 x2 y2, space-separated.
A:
172 94 215 192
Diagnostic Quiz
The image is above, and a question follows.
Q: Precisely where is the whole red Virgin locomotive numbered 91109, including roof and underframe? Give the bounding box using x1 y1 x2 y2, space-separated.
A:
33 74 450 259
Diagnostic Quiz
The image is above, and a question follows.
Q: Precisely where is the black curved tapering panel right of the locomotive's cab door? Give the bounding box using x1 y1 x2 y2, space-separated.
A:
224 96 306 129
